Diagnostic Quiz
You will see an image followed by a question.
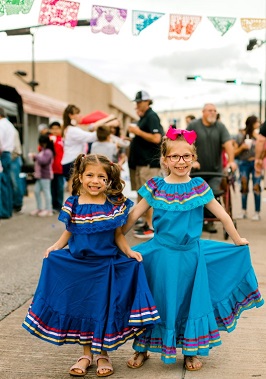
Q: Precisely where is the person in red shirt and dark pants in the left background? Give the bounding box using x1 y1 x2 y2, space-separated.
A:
49 121 65 212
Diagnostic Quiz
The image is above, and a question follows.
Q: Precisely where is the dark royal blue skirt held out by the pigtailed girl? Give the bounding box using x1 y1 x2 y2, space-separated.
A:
23 249 160 354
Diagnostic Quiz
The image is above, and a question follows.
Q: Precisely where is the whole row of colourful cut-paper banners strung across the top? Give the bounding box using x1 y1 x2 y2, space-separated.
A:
0 0 266 40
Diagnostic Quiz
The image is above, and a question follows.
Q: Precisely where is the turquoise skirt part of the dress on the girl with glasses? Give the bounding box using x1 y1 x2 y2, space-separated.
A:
133 236 264 363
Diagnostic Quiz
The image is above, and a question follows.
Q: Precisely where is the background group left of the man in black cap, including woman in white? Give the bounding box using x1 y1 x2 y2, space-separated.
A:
0 104 130 219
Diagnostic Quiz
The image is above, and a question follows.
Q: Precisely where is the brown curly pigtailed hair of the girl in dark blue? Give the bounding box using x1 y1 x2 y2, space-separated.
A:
72 154 126 205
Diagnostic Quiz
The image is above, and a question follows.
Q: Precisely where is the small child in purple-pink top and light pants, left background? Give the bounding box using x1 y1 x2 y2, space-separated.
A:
29 134 54 217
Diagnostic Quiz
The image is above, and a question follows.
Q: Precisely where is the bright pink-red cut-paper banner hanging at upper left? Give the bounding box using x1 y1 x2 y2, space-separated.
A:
39 0 80 28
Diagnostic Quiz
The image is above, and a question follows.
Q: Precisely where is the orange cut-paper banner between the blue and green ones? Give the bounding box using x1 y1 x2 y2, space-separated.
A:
168 14 201 40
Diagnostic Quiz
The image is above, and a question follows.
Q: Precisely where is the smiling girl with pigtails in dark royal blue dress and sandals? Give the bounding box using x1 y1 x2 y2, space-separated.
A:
23 154 160 376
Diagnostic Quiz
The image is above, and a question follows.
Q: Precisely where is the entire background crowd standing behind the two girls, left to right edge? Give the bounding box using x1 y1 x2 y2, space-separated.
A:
0 91 266 226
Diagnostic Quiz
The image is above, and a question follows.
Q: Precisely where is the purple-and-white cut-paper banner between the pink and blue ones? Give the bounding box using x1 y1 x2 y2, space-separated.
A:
90 5 127 34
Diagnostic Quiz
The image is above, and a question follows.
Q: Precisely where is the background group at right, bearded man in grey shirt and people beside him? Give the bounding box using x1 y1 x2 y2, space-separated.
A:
186 104 266 227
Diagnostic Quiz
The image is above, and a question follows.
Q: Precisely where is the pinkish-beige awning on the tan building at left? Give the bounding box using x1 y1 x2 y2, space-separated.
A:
16 88 67 119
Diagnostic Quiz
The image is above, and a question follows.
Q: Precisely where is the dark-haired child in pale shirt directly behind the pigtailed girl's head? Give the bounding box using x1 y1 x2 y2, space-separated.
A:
91 125 118 163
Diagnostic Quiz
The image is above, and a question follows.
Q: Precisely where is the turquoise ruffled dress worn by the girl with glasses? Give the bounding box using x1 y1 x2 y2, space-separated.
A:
130 177 264 363
